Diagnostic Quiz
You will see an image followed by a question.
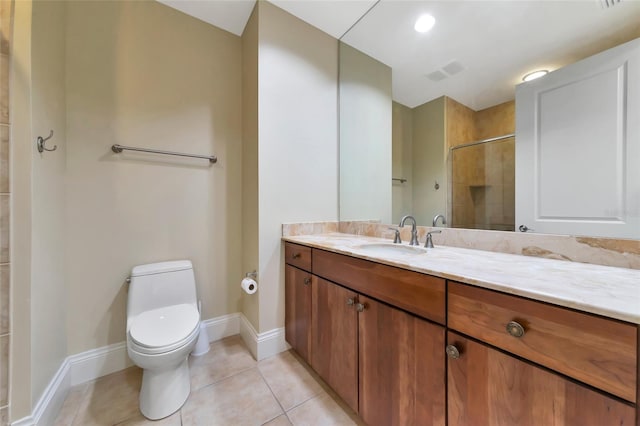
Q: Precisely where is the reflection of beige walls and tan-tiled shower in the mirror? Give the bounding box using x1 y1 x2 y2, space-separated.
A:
392 96 515 226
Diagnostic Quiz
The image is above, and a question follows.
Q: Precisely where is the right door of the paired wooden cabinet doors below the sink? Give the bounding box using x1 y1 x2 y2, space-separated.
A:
358 296 446 426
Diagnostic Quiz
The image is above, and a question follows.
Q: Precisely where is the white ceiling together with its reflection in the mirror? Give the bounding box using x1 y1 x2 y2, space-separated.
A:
159 0 640 110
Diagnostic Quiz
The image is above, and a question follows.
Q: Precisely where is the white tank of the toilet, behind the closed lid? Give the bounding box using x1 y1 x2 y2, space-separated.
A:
127 260 198 319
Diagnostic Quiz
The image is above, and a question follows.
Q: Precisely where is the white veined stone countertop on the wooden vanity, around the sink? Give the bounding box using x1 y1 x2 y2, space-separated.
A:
282 233 640 324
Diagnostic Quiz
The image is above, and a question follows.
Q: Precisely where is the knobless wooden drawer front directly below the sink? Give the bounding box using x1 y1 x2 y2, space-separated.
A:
312 249 446 325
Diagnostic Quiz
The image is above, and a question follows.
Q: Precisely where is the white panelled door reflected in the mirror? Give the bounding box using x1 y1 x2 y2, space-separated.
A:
516 39 640 239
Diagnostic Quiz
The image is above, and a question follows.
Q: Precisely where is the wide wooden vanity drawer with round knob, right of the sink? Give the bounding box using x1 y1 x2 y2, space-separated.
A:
448 281 638 402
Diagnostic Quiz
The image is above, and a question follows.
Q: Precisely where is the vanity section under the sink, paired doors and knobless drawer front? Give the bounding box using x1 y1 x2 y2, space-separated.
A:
310 249 445 426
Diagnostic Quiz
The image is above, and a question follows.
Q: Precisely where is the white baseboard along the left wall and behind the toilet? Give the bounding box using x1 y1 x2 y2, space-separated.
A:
11 313 246 426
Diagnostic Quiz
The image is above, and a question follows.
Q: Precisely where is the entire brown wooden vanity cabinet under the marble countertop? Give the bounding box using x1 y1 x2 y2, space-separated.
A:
285 243 640 426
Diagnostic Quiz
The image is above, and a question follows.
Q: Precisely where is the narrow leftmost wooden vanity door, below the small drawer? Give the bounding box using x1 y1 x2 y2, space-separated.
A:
284 265 312 362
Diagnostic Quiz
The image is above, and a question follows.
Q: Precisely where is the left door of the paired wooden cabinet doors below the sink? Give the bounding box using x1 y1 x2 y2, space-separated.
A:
311 275 358 412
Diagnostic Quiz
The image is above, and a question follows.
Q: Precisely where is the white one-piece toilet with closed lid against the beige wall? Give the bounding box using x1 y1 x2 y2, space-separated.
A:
127 260 200 420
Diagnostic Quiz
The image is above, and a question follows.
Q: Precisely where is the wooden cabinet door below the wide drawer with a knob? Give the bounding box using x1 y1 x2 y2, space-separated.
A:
447 332 635 426
